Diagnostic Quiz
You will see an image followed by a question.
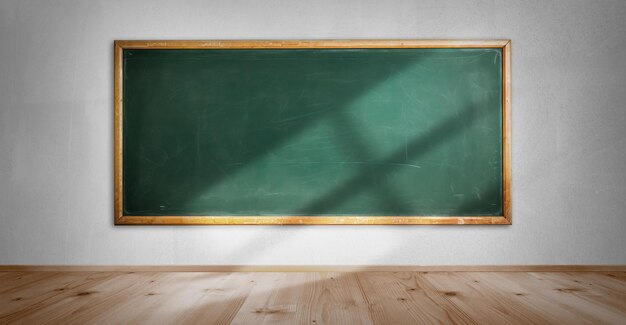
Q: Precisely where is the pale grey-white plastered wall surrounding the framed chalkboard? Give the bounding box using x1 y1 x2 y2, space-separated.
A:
0 0 626 265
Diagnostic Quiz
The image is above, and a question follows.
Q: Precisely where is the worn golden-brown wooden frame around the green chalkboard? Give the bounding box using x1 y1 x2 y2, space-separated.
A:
114 40 512 225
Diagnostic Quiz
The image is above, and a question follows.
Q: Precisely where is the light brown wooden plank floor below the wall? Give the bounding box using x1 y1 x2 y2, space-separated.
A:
0 272 626 325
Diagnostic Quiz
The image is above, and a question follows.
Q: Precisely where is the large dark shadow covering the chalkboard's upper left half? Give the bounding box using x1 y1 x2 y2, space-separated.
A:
123 50 420 215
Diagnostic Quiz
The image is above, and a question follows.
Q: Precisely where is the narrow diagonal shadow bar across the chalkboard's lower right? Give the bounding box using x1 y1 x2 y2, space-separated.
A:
301 104 498 214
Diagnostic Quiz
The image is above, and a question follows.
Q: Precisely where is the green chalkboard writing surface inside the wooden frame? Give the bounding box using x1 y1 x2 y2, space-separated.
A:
114 39 504 224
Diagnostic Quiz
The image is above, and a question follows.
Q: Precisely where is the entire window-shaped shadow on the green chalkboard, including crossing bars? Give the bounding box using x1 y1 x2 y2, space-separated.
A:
124 50 500 215
